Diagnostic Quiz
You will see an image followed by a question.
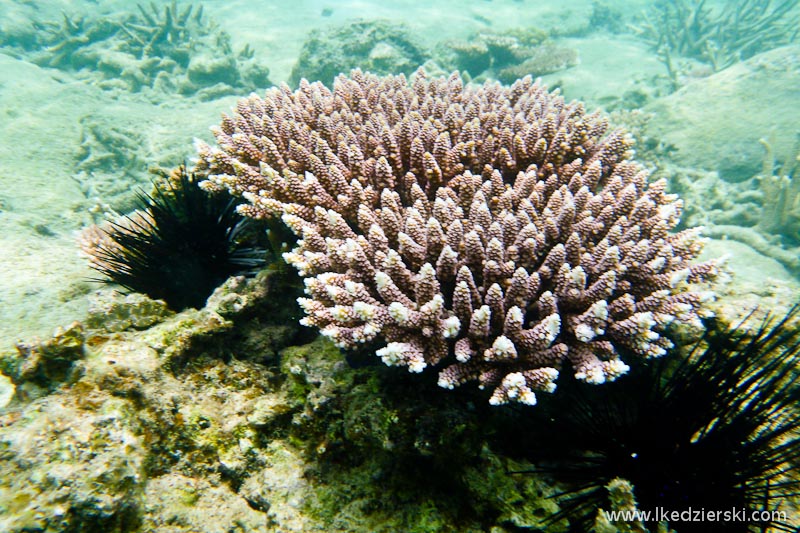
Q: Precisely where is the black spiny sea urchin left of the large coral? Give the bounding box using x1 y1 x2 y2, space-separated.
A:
83 167 265 311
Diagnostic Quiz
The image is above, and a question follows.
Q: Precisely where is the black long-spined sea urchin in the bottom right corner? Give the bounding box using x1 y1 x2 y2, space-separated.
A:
510 306 800 533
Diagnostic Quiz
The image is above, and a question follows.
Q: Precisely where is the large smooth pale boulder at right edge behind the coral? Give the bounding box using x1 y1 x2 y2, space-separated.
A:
645 45 800 182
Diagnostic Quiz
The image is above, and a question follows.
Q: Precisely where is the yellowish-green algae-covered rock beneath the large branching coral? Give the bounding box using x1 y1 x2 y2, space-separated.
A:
0 272 592 533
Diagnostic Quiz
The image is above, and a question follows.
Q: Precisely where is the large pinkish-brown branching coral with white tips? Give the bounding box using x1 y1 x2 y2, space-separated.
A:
197 70 717 405
